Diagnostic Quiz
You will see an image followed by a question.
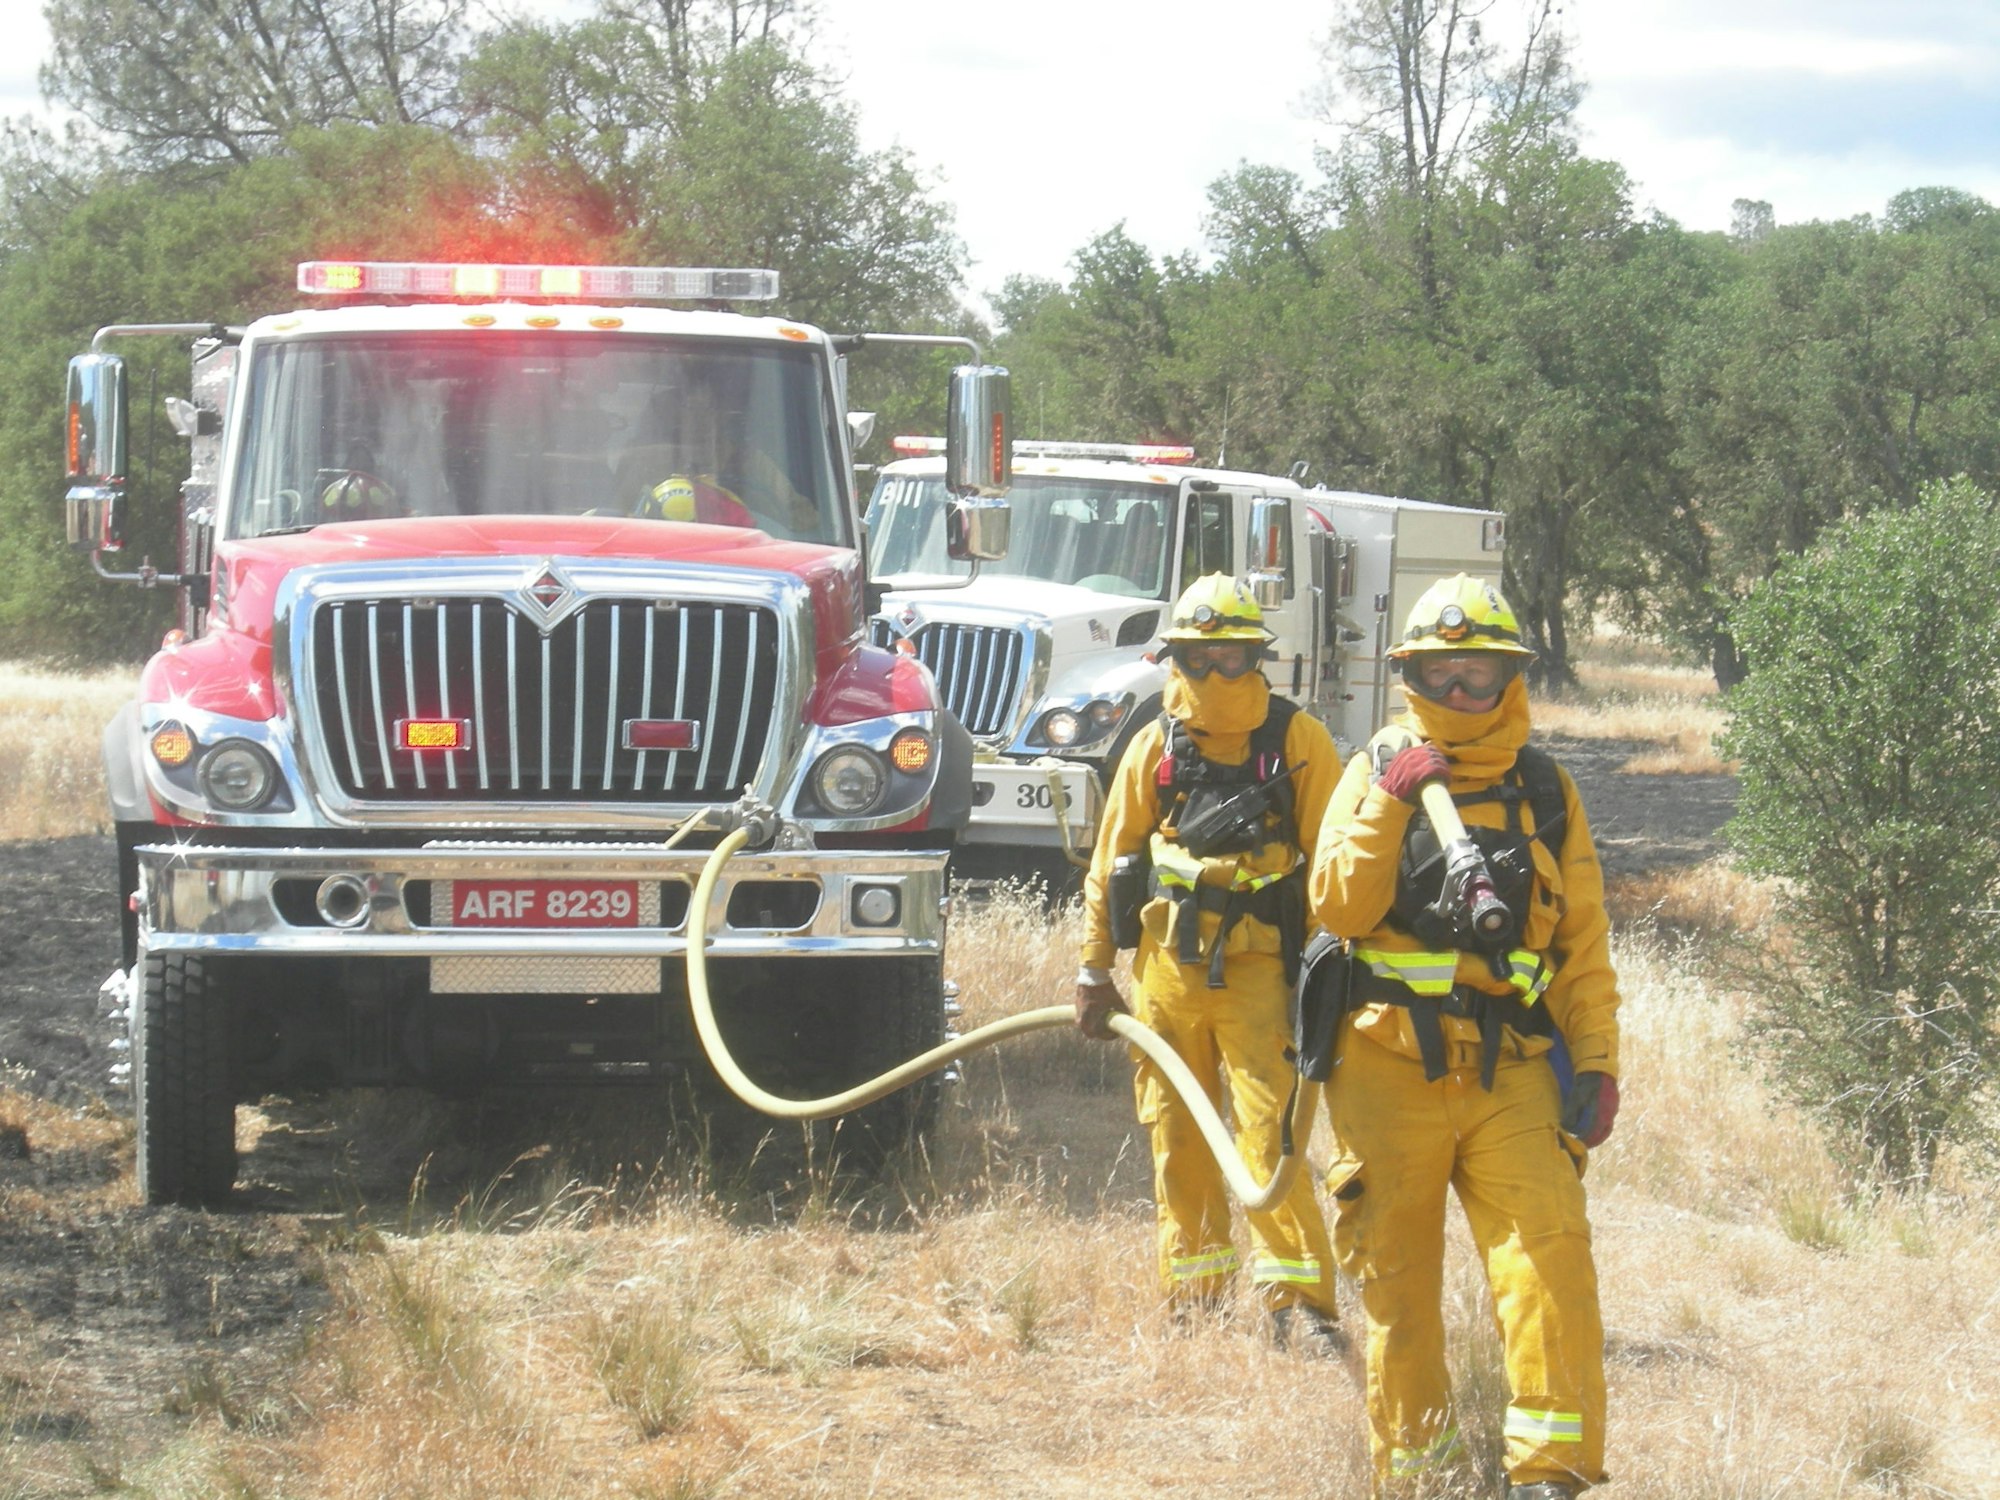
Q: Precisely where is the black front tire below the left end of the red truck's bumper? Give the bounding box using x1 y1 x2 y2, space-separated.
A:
132 954 236 1208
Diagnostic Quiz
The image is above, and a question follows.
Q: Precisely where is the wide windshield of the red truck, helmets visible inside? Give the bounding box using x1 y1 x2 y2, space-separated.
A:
224 330 848 544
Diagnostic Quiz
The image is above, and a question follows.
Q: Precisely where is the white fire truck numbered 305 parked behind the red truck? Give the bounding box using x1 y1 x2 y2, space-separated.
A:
868 438 1504 860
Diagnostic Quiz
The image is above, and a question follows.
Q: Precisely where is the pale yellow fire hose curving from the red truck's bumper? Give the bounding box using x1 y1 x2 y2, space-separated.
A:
688 826 1320 1212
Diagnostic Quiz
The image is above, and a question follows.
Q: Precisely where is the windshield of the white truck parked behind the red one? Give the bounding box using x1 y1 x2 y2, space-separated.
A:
868 474 1180 598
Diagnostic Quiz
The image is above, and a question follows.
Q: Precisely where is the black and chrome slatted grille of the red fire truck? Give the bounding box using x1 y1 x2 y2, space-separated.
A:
308 598 778 802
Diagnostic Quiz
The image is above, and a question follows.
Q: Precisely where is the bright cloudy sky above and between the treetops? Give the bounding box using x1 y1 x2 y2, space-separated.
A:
0 0 2000 292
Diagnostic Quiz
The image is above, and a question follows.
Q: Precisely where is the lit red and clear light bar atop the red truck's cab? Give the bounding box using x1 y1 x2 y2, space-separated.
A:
298 260 778 302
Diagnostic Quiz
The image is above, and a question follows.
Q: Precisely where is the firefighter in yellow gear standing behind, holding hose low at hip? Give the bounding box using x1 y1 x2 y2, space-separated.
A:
1076 574 1344 1354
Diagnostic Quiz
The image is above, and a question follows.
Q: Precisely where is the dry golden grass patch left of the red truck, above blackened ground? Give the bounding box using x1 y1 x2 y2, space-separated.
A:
0 664 134 838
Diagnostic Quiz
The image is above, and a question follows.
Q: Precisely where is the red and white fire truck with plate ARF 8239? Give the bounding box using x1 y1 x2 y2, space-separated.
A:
68 262 1006 1202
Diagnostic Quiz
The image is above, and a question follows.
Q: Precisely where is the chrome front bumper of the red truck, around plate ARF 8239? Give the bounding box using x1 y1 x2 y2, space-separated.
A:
138 842 946 960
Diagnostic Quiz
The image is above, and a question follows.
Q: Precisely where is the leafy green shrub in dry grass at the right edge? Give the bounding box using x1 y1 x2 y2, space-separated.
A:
1722 480 2000 1180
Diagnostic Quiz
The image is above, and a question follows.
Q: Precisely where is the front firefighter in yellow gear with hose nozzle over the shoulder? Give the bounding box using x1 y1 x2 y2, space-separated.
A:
1310 574 1618 1500
